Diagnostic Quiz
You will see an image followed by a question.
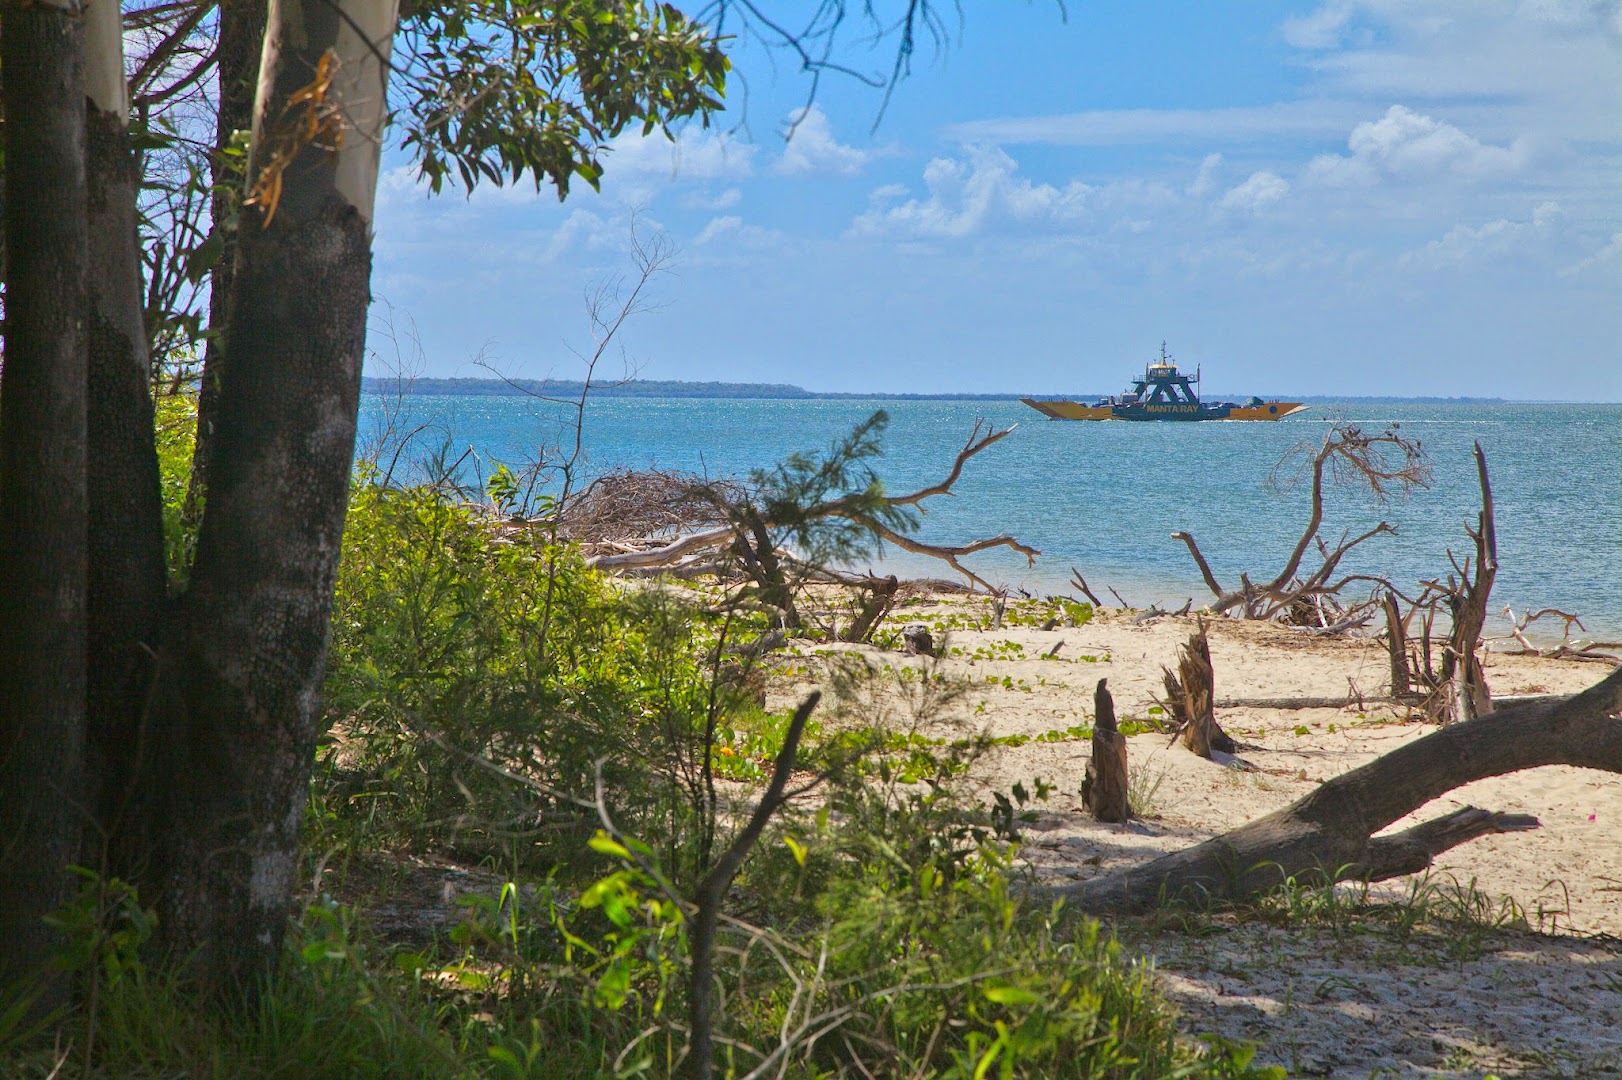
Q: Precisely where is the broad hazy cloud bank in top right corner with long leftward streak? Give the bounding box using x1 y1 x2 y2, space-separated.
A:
944 0 1622 159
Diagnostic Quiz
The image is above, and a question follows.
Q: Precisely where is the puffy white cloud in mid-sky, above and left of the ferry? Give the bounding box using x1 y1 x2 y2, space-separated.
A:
853 146 1092 238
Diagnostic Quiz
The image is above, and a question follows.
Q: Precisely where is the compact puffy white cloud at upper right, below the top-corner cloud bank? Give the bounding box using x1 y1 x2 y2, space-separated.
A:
1307 105 1528 186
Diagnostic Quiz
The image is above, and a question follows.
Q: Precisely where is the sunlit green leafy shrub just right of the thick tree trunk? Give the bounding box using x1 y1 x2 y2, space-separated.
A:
316 483 772 872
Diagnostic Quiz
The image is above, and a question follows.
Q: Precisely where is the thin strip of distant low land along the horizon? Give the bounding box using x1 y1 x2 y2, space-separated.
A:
360 376 1518 405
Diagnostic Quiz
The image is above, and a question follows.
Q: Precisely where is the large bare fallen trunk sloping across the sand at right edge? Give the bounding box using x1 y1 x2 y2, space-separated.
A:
1058 668 1622 913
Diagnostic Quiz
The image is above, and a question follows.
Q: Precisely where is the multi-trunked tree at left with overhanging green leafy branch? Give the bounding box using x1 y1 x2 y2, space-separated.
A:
0 0 727 988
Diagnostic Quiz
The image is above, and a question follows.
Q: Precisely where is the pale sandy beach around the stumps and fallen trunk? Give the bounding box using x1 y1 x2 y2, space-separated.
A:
772 598 1622 1077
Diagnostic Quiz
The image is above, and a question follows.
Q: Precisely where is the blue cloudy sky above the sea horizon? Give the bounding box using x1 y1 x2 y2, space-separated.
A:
368 0 1622 401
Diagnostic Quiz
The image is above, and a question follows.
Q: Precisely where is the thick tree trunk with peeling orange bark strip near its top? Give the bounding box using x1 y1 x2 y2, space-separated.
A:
146 0 396 986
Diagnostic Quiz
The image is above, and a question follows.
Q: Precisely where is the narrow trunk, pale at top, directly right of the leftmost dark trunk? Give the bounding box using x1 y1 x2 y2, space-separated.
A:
84 0 165 881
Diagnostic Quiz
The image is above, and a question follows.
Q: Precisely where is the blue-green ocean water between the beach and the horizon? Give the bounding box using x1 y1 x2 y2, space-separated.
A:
362 396 1622 641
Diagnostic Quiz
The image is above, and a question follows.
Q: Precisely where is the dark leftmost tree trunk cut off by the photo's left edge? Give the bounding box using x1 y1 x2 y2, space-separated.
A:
0 0 88 979
